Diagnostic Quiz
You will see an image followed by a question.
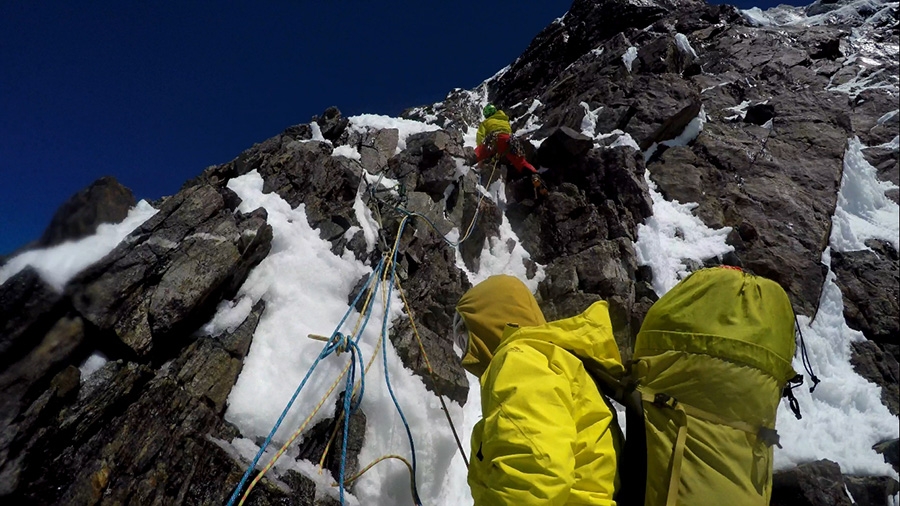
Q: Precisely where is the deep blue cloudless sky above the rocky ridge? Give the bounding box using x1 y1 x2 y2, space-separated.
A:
0 0 800 255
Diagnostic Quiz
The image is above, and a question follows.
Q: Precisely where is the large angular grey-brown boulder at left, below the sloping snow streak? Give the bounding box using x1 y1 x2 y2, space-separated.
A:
67 186 272 355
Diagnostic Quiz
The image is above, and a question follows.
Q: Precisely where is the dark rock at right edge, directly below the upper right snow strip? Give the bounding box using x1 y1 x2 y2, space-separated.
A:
831 241 900 344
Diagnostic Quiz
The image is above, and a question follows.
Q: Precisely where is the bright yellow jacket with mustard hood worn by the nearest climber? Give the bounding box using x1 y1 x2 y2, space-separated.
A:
457 276 623 506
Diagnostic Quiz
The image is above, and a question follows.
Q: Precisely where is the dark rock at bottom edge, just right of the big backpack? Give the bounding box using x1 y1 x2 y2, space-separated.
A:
769 460 853 506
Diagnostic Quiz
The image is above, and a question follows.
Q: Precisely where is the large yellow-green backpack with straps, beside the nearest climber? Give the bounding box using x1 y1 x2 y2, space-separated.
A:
586 267 818 506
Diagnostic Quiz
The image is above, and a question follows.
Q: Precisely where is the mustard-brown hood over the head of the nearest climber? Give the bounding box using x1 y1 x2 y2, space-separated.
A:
456 275 547 377
